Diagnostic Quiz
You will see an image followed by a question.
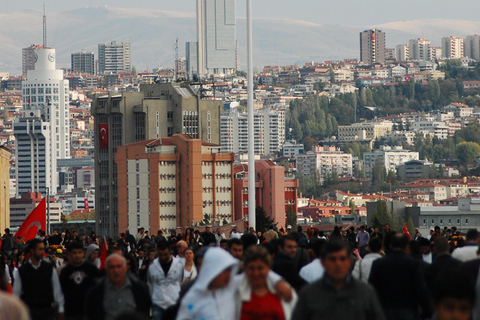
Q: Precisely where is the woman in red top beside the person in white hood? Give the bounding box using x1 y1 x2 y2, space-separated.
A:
240 246 290 320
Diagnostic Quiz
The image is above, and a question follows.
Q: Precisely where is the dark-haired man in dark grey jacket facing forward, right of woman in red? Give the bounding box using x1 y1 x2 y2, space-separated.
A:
292 240 385 320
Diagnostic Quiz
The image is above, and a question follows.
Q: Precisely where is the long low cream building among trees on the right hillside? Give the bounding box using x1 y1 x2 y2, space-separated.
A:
338 121 393 141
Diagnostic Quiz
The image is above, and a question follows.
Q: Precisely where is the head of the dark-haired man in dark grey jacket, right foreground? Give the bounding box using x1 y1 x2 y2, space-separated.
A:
320 240 352 285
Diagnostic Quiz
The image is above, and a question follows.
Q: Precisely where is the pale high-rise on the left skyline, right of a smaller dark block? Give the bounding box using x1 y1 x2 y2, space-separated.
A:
98 41 131 74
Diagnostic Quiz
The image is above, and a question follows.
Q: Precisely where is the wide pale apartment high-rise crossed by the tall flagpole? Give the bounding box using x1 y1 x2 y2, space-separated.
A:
220 108 285 155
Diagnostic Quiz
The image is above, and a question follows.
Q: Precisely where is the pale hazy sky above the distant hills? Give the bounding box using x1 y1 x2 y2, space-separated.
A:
0 0 480 26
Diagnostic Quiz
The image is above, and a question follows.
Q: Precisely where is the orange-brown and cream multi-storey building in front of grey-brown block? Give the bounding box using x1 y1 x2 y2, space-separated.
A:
115 134 235 232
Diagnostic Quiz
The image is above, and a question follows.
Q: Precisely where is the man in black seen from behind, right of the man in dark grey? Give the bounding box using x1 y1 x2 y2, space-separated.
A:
369 233 432 320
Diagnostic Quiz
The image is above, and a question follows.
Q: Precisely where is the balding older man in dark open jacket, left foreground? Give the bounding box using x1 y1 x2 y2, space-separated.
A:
85 253 152 320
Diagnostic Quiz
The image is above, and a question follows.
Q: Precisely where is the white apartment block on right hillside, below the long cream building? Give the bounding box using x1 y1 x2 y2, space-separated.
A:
363 146 419 179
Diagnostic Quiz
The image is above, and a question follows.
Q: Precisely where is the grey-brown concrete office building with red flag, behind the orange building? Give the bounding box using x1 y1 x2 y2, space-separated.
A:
92 83 223 236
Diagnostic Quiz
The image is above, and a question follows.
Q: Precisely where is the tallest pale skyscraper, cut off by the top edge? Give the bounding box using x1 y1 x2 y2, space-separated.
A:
197 0 236 76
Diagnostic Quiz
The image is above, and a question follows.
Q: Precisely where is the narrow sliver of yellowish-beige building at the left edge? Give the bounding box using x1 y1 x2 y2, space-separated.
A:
0 146 10 232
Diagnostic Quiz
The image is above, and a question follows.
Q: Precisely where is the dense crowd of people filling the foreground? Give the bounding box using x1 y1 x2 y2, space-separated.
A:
0 225 480 320
